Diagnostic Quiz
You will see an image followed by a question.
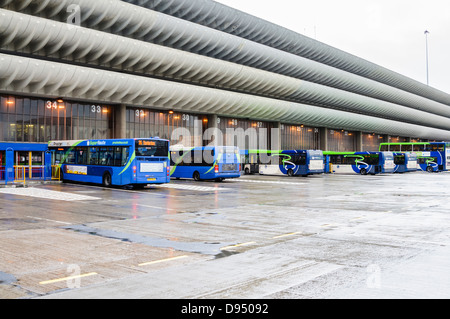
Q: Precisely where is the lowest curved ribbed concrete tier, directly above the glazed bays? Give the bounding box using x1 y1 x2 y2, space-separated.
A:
0 54 450 140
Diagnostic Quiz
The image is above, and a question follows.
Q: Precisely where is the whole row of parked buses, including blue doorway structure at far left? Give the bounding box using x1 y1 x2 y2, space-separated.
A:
0 138 450 187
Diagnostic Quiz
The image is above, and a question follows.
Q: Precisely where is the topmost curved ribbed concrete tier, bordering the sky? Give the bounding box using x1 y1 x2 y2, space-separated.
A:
123 0 450 105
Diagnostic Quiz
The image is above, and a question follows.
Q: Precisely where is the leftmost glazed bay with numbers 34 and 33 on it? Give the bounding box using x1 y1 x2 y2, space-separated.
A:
0 95 114 143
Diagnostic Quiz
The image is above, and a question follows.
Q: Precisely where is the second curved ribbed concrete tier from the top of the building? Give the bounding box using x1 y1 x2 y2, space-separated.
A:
0 0 450 121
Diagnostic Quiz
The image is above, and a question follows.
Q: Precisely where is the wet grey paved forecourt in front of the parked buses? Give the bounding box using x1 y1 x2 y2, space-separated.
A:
0 172 450 299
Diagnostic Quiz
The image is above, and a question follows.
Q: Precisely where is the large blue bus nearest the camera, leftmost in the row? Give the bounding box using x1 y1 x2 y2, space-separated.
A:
48 138 170 187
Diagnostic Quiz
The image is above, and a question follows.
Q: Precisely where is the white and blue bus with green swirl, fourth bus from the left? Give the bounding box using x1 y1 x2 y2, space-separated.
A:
324 152 395 175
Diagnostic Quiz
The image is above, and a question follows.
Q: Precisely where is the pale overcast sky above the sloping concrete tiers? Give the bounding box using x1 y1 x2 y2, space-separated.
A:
216 0 450 93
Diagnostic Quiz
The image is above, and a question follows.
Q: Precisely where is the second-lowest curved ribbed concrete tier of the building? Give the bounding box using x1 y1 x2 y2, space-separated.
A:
0 9 450 129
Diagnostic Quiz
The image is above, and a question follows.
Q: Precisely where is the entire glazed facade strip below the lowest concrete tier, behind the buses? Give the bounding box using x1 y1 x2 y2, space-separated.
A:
0 95 422 152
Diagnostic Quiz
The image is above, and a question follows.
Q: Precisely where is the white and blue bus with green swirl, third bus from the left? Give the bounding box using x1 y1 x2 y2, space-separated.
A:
259 150 324 177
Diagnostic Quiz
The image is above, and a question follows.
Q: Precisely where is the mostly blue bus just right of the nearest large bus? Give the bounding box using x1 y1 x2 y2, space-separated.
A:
170 146 241 182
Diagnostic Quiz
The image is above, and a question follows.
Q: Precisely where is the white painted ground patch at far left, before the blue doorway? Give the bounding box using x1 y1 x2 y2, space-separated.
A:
0 187 100 202
